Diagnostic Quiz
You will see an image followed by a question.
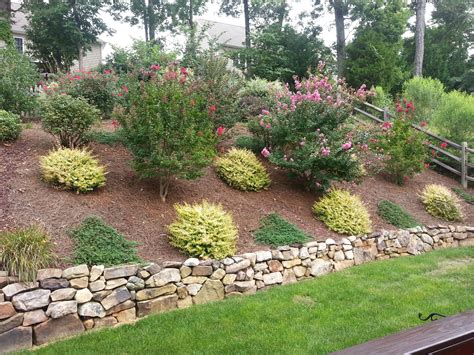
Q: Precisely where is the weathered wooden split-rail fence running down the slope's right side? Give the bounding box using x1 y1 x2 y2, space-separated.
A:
354 102 474 188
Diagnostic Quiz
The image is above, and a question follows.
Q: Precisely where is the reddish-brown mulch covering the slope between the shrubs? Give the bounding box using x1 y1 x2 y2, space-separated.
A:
0 125 474 261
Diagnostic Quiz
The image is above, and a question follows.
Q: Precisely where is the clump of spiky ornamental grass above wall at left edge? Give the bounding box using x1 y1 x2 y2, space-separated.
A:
0 226 54 281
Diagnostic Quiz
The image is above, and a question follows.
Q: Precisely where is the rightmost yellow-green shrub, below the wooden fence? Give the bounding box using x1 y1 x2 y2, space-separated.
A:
421 184 463 221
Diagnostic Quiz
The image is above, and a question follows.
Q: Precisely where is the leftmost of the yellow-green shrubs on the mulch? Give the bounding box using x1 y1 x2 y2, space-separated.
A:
40 148 106 193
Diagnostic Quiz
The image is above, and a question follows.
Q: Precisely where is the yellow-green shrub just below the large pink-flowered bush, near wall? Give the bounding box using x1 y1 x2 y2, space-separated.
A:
313 189 372 235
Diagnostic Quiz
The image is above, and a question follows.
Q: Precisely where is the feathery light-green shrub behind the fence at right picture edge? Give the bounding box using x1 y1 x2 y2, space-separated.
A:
430 91 474 147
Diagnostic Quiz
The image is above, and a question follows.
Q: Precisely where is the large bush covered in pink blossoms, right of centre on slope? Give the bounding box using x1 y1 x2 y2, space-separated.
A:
252 65 369 190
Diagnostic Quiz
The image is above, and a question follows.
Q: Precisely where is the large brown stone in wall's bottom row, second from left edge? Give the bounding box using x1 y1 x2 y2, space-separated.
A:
33 314 84 345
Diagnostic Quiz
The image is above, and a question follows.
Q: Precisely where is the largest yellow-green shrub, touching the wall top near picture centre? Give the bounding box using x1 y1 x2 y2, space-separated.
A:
168 201 237 259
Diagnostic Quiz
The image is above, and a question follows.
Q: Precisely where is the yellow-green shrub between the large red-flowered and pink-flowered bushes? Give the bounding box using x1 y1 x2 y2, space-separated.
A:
216 148 270 191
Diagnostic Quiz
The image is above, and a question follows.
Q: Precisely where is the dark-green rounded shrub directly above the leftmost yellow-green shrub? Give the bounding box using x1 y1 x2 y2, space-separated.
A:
41 94 99 148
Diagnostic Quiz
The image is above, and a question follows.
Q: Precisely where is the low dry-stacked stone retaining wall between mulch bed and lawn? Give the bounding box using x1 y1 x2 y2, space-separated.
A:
0 225 474 353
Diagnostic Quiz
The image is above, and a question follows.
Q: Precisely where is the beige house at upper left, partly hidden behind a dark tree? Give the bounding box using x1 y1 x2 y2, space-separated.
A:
6 2 105 71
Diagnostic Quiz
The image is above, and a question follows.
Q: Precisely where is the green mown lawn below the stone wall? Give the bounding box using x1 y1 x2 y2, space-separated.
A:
29 248 474 354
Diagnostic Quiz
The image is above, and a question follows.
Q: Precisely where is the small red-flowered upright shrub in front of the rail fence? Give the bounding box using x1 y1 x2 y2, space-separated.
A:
374 103 427 185
